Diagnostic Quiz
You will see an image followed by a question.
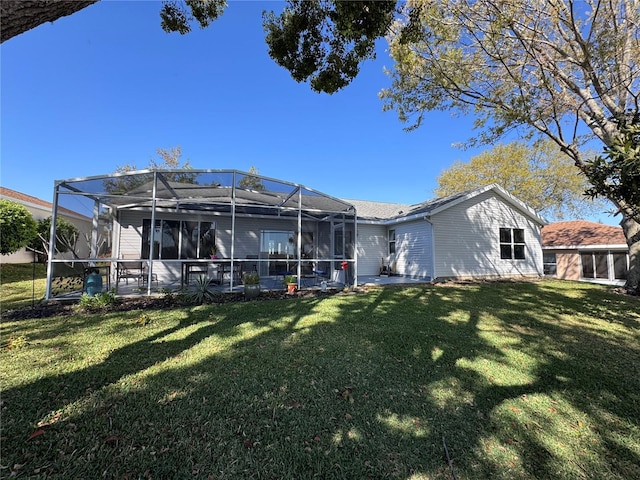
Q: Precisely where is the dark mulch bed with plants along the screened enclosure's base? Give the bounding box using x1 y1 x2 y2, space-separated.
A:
2 289 356 320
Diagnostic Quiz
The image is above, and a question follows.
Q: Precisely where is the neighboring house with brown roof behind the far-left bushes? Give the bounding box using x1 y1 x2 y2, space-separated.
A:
0 187 92 263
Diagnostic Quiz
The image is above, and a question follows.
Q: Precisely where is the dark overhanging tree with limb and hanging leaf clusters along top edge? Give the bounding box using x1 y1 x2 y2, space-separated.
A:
0 0 396 93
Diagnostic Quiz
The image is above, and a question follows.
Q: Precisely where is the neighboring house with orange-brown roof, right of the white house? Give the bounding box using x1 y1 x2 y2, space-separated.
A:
542 220 629 285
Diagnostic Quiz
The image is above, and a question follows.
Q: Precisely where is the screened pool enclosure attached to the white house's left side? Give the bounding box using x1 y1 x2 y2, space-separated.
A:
46 169 357 299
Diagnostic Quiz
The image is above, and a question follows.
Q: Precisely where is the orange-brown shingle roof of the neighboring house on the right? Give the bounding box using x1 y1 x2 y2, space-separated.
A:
542 220 627 247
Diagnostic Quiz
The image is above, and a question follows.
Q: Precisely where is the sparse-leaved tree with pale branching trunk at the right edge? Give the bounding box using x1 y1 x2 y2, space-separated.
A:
381 0 640 291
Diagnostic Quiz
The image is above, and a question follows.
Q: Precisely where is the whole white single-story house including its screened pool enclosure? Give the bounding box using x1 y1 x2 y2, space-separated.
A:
47 170 546 298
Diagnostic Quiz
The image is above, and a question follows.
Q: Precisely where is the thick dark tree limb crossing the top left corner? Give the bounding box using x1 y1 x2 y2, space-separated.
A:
0 0 98 43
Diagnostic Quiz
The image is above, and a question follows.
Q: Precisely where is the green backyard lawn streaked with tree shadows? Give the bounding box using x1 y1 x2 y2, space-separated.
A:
0 268 640 480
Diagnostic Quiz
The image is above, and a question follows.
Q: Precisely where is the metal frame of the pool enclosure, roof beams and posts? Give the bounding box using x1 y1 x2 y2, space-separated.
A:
45 169 358 300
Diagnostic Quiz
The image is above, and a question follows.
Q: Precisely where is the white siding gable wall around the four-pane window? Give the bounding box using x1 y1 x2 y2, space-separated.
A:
431 191 542 278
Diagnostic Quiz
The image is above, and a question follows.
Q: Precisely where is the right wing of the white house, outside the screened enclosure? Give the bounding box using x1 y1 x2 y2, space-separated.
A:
348 184 546 280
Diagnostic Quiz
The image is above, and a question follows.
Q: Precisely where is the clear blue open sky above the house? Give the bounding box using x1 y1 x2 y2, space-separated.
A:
0 1 617 223
